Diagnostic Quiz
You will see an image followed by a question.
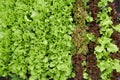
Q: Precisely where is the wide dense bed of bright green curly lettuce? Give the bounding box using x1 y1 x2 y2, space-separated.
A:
0 0 74 80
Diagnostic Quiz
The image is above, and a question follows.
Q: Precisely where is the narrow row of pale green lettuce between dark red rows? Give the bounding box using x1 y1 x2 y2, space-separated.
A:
86 0 120 80
